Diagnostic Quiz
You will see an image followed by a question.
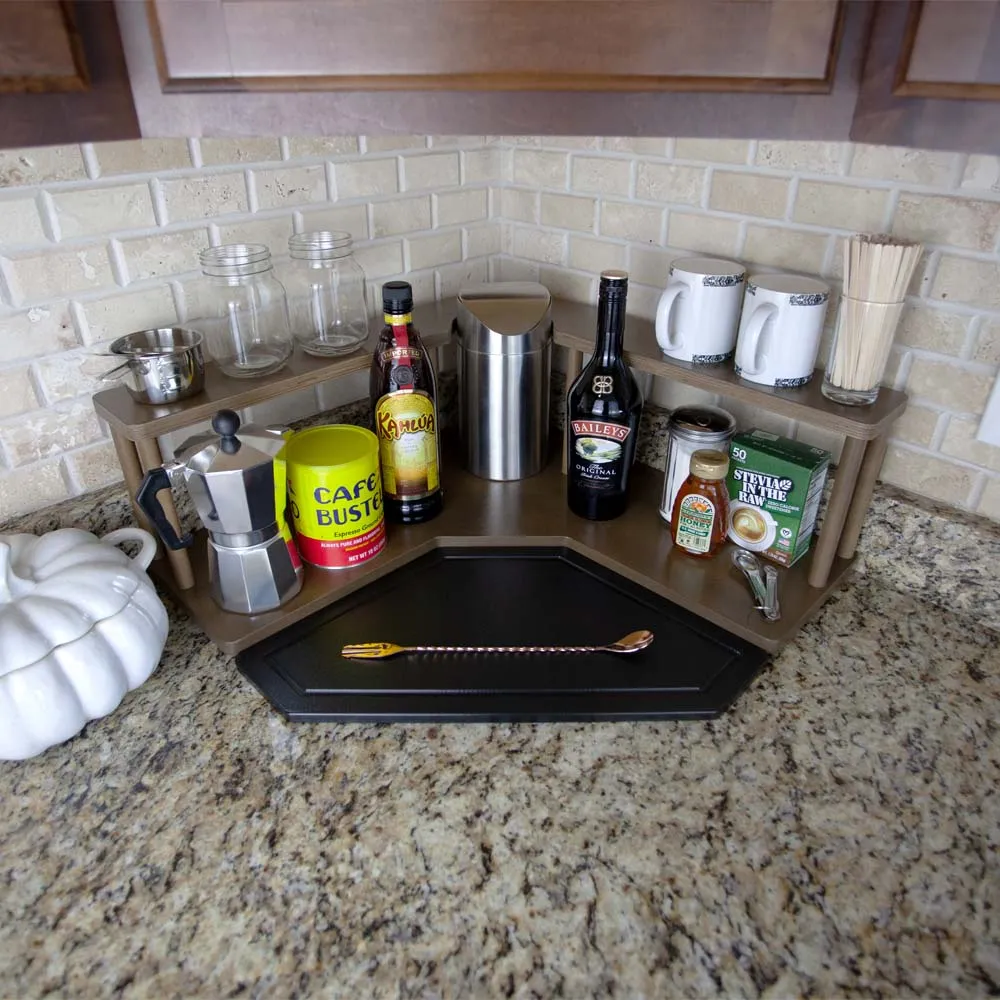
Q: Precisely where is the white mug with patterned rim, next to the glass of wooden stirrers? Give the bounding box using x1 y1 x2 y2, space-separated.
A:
736 274 830 389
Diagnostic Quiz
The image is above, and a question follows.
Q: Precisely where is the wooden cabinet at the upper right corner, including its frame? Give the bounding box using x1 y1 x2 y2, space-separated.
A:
851 0 1000 153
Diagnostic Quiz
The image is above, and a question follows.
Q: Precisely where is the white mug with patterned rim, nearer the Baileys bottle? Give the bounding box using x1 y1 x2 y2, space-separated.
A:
656 257 746 365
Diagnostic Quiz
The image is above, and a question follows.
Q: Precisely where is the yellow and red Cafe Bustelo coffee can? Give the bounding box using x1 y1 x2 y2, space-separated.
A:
284 424 385 569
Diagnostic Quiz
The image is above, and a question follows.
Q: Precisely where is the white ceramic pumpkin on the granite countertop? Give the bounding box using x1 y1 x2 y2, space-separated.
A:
0 528 167 760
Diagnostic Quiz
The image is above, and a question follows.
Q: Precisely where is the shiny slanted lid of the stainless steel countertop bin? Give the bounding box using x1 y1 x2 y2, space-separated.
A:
455 281 552 354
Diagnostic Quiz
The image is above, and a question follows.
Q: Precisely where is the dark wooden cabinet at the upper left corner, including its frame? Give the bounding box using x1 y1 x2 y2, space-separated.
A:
0 0 139 147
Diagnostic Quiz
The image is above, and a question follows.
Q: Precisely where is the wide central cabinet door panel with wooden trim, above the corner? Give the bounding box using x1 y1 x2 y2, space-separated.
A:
154 0 840 92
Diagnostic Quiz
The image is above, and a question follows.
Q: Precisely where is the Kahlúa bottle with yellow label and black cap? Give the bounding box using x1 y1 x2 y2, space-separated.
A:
370 281 442 524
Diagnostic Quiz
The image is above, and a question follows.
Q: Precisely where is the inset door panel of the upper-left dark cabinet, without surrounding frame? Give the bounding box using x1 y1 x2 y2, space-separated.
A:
0 0 87 94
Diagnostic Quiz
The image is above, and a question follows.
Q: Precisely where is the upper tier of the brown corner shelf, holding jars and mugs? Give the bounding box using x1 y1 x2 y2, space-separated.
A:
94 299 906 441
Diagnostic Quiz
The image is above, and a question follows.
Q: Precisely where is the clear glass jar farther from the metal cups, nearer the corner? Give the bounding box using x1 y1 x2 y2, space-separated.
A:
285 232 368 357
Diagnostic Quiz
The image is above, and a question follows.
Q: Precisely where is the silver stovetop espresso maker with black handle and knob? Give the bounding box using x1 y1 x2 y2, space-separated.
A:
136 410 302 615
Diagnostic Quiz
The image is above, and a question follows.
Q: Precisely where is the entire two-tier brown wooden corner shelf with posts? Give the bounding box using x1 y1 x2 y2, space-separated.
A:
94 299 906 653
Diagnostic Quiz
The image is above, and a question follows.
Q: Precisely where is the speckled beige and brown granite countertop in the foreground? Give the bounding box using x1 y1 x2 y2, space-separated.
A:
0 560 1000 998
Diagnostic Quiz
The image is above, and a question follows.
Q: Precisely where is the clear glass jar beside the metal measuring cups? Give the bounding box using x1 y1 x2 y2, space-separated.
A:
188 243 292 378
